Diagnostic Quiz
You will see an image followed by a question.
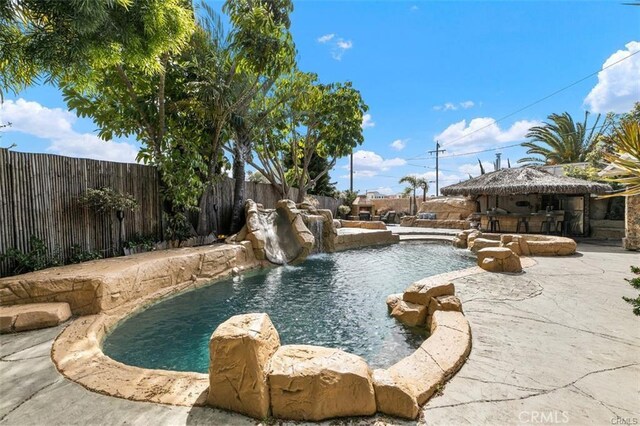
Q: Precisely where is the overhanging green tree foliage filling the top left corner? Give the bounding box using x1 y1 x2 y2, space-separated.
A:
0 0 194 92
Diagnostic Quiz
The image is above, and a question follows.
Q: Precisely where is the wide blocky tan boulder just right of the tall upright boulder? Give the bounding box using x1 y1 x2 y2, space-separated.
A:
269 345 376 421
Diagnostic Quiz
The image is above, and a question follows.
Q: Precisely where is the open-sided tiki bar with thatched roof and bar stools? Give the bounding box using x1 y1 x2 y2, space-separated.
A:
442 167 612 236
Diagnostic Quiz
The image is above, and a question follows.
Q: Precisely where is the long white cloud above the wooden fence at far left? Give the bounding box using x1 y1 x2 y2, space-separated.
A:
0 99 138 163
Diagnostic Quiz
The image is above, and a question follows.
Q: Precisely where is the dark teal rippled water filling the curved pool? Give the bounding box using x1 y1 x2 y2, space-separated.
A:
103 242 474 373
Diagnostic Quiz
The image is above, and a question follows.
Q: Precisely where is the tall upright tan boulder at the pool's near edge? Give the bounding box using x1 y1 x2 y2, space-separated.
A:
207 313 280 419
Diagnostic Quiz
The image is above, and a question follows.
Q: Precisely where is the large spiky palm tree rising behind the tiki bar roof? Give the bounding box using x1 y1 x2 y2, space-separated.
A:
518 111 609 164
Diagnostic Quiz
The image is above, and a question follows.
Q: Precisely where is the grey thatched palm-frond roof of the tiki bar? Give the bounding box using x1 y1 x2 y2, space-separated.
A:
442 166 613 195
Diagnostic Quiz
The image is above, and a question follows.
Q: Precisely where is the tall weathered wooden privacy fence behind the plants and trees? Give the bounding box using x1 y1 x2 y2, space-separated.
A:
0 149 340 276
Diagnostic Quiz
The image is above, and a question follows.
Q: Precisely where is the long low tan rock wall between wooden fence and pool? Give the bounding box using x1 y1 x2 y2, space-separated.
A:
0 243 259 315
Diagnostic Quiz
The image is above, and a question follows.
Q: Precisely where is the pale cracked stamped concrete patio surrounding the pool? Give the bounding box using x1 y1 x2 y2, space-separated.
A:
0 244 640 425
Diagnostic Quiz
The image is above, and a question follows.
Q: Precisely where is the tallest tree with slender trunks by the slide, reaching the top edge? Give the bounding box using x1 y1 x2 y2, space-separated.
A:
195 0 295 233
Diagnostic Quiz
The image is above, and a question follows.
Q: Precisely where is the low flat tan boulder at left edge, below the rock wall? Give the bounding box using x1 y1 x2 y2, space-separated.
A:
0 302 71 333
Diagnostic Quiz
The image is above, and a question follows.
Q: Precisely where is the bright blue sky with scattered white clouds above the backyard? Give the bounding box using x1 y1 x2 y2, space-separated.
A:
0 1 640 194
